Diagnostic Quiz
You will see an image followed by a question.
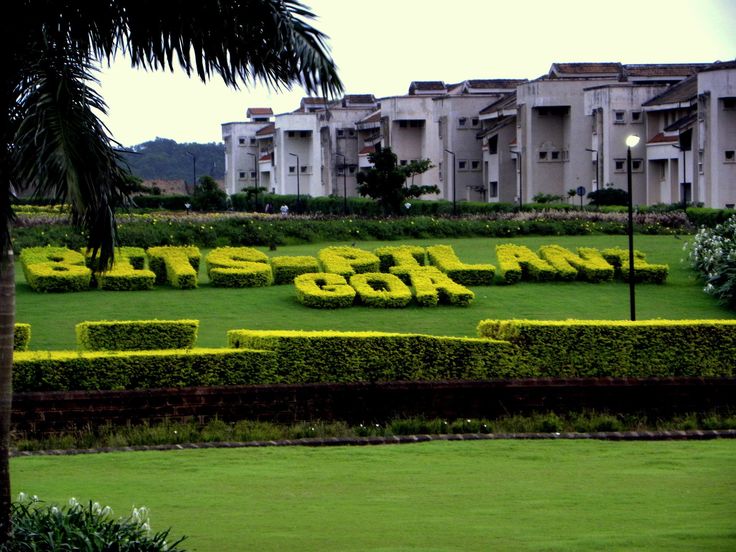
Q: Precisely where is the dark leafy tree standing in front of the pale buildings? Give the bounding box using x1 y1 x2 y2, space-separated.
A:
358 148 440 215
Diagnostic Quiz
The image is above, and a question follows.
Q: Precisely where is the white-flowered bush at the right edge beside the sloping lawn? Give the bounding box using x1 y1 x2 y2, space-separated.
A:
689 216 736 308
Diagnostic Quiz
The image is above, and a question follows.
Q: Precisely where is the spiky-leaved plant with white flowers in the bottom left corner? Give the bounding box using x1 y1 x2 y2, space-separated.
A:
5 493 184 552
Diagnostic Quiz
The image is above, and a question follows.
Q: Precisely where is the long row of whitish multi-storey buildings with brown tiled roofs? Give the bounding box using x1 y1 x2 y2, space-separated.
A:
223 58 736 207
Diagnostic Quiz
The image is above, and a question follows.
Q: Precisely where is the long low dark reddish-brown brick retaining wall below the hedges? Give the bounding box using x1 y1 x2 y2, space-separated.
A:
12 378 736 435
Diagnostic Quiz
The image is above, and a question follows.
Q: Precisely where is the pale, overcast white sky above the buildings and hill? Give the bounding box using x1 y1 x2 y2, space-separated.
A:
99 0 736 146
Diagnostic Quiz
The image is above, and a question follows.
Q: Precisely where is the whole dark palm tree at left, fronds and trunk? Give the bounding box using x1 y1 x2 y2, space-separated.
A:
0 0 343 547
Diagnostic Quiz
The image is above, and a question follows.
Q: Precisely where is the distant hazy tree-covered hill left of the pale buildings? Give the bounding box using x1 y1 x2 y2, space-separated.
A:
123 138 225 181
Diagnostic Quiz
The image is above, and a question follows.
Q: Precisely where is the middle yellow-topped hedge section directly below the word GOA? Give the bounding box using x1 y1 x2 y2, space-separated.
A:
227 330 515 383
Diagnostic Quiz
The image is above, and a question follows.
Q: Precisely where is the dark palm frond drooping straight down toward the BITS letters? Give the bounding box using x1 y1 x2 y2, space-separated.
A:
12 37 131 266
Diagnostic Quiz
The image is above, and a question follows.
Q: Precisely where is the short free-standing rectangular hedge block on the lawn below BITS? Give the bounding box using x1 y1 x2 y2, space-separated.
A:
75 320 199 351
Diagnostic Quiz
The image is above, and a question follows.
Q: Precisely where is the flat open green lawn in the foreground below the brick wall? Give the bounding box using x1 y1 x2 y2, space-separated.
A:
11 440 736 552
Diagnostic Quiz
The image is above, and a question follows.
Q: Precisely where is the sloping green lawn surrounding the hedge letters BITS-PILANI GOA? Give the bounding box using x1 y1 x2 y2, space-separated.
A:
17 236 734 350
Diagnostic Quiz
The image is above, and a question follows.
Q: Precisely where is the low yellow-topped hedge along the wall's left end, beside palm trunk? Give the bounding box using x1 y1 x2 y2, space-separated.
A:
13 349 276 392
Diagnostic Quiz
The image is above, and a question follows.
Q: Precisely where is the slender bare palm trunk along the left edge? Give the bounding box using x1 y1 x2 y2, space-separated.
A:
0 248 15 545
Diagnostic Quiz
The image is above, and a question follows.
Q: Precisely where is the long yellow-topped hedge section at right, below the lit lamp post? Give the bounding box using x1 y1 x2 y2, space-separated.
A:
478 320 736 377
